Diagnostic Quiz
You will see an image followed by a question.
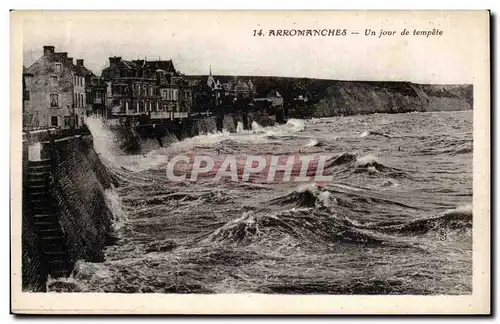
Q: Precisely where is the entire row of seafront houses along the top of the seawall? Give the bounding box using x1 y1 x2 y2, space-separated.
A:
23 46 292 129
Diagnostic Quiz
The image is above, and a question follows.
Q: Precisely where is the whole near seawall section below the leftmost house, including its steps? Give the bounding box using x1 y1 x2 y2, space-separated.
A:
22 135 112 291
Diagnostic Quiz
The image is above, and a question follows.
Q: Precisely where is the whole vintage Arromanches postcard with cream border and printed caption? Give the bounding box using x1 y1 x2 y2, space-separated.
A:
11 11 490 314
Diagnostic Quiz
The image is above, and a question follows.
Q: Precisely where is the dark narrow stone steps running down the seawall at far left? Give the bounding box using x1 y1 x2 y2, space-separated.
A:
27 160 70 278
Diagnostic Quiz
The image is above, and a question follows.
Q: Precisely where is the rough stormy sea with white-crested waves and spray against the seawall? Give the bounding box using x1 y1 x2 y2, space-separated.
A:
49 111 473 295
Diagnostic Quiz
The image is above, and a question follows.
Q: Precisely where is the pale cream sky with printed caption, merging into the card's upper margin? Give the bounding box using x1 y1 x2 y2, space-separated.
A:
22 11 487 83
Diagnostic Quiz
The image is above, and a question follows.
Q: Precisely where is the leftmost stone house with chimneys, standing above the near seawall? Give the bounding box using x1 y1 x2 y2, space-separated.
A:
23 46 87 129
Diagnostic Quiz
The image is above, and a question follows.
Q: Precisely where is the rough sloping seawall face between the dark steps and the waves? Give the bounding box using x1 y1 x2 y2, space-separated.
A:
51 136 112 262
